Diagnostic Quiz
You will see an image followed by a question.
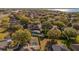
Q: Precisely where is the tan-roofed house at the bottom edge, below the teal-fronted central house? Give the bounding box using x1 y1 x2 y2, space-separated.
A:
20 37 40 51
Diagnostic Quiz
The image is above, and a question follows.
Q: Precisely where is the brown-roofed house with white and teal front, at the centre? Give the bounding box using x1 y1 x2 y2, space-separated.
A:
28 24 44 37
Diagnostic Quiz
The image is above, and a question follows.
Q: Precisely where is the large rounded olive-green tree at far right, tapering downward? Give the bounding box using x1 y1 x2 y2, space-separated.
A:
62 27 77 49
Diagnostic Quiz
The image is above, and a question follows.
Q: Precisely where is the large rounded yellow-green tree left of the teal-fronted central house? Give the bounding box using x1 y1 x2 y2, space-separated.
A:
12 29 31 45
